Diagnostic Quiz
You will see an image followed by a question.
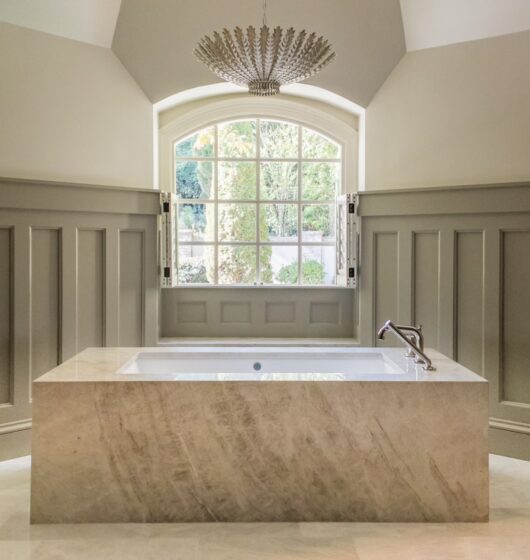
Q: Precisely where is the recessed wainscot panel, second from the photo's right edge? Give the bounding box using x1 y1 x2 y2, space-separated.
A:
455 232 484 374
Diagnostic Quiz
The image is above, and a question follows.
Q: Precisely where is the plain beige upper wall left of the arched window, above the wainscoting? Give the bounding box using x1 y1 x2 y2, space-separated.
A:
0 23 153 188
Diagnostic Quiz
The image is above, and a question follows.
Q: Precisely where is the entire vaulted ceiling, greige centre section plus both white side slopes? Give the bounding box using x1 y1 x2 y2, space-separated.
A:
0 0 530 106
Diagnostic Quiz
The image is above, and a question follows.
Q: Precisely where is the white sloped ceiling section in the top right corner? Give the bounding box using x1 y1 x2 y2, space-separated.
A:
401 0 530 51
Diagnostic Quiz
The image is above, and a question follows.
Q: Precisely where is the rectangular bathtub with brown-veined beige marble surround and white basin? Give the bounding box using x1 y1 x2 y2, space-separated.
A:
31 347 489 523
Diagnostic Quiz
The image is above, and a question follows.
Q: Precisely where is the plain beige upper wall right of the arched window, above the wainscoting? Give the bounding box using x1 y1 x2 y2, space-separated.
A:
366 31 530 189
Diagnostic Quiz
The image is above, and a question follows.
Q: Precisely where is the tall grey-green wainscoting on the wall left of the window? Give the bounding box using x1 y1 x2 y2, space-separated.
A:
0 179 159 460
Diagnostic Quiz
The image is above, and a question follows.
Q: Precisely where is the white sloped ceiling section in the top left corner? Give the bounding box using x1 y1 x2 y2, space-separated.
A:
0 0 121 48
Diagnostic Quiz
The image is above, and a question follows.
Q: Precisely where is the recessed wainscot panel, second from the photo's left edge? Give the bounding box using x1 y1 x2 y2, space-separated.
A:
31 228 61 379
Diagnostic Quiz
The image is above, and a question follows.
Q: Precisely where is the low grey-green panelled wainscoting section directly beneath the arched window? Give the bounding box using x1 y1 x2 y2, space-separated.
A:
161 287 356 339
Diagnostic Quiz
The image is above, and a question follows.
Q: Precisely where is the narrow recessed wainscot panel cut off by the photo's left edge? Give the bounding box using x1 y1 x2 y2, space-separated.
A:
0 228 13 404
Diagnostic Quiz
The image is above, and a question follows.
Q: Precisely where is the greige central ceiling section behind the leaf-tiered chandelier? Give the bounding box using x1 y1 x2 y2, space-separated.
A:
112 0 405 105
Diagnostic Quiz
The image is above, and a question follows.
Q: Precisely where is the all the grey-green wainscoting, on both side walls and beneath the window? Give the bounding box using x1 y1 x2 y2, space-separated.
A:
0 180 530 460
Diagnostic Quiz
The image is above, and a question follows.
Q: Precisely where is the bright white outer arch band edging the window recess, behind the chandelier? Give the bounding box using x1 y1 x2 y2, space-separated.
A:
153 82 366 191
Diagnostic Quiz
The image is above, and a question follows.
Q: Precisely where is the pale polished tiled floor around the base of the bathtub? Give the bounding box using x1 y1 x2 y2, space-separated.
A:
0 456 530 560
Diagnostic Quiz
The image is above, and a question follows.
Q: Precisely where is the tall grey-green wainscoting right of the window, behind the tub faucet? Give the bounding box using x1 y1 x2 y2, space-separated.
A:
359 184 530 460
